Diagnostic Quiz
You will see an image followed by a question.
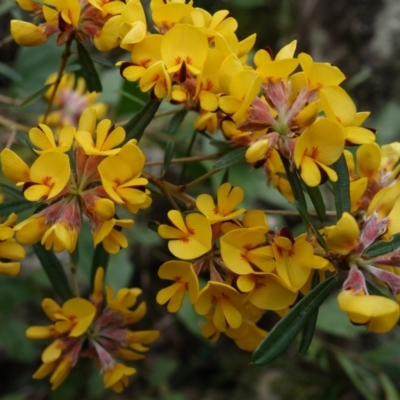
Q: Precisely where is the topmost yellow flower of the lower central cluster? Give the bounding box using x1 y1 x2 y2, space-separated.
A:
196 183 245 224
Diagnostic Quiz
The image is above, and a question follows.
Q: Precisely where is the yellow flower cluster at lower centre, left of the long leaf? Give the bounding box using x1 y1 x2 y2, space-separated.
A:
157 183 333 351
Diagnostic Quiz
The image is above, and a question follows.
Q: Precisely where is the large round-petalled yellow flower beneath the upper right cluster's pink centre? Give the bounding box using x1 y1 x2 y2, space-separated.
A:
293 118 345 187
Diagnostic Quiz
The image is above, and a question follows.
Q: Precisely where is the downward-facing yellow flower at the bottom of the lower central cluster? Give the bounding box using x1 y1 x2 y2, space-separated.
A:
195 281 243 332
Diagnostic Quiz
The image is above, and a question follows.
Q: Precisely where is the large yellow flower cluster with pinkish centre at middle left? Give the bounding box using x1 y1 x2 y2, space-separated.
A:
1 108 151 254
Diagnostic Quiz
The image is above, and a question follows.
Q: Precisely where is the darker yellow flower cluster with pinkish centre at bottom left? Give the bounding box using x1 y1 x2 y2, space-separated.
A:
26 267 159 393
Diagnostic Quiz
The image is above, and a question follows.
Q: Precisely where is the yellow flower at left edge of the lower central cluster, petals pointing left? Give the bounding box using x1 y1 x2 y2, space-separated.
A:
158 210 211 260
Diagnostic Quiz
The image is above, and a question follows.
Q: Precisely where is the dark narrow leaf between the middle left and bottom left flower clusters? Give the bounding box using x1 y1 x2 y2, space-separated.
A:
33 243 74 301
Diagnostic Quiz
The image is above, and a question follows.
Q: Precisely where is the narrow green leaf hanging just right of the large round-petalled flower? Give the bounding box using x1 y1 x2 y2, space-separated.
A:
330 154 351 219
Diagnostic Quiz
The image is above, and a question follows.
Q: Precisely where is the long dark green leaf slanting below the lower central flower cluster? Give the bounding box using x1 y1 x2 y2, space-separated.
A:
252 276 337 365
